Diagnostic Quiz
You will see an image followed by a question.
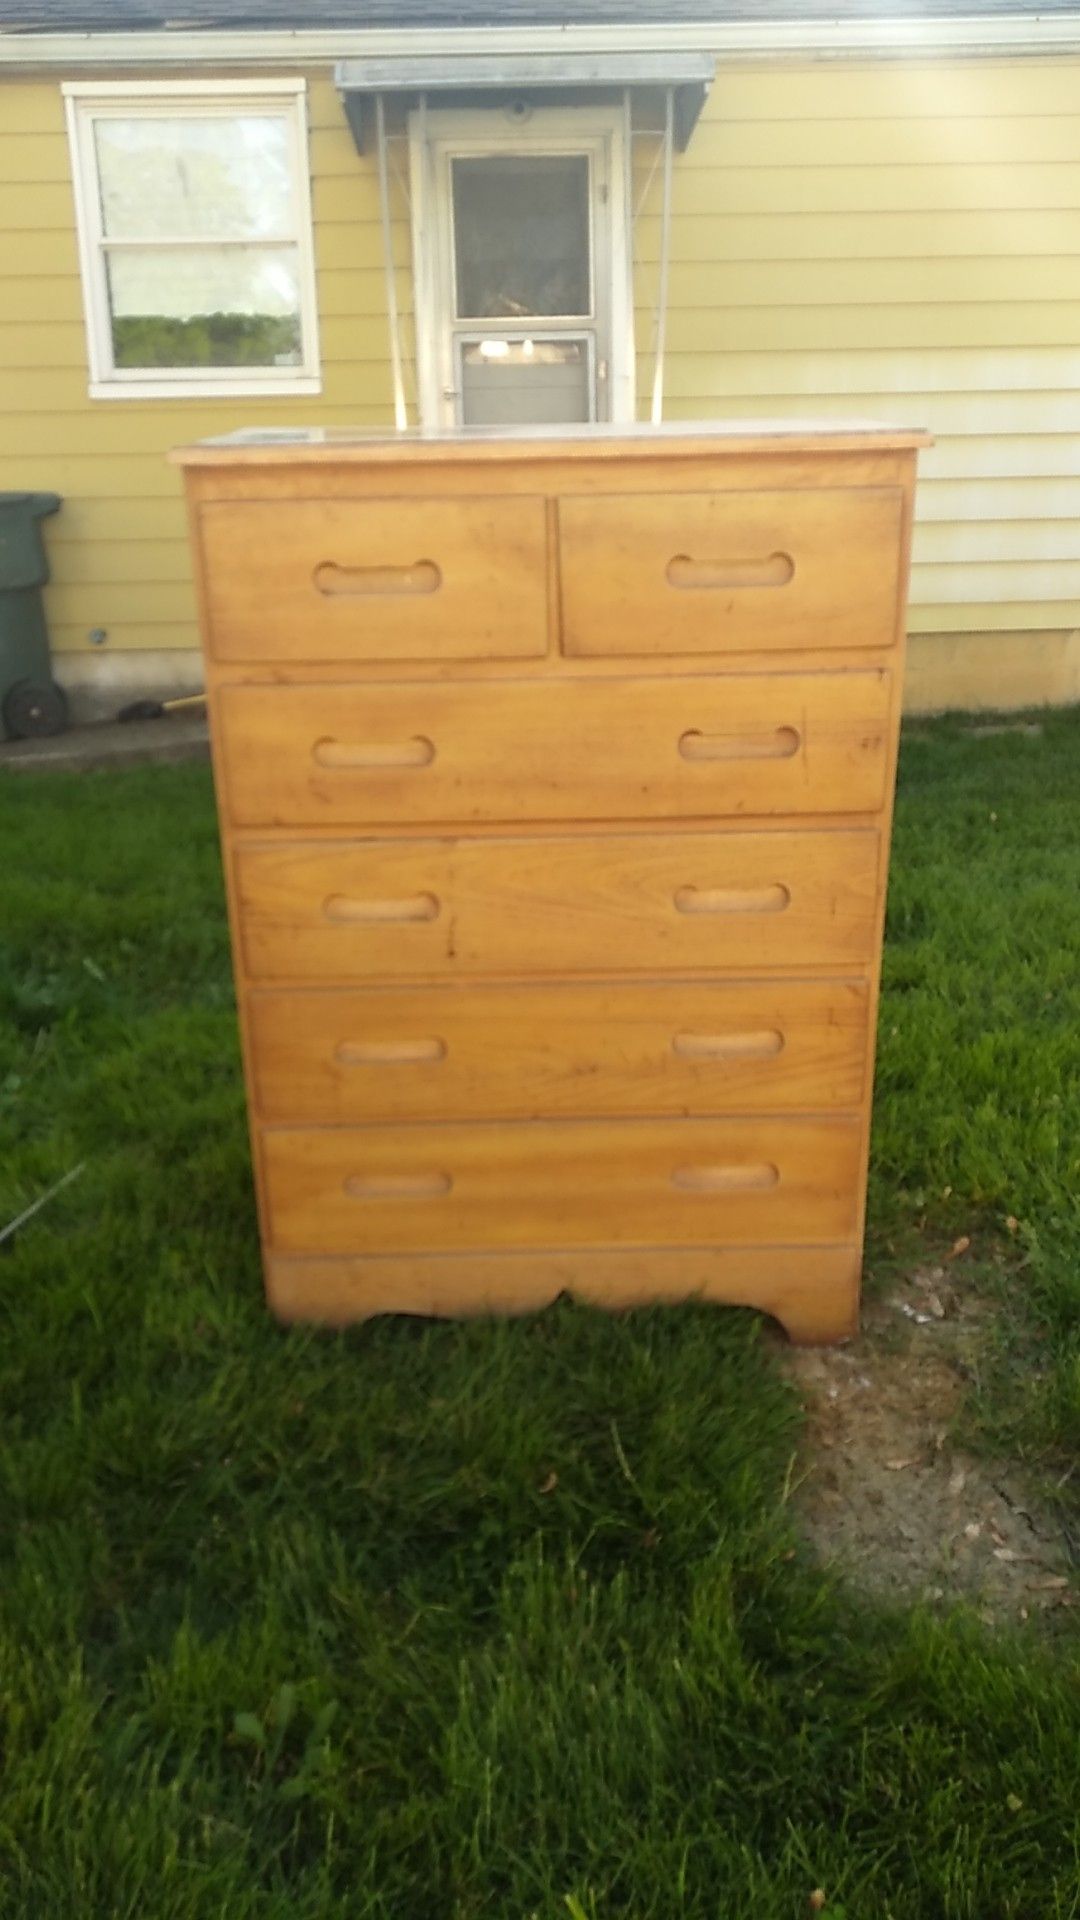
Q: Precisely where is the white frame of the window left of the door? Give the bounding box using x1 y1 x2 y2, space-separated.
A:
61 79 323 399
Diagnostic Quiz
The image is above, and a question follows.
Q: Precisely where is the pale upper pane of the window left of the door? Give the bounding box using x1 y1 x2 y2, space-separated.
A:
94 113 292 240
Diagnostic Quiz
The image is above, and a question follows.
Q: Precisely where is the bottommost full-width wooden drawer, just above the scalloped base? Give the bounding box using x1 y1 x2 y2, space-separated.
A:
259 1119 861 1254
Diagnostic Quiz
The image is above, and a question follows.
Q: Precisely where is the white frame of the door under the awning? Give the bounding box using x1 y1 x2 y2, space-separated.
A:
409 106 636 432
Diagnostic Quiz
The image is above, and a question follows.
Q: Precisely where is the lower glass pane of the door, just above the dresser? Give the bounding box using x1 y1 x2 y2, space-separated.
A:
461 338 592 426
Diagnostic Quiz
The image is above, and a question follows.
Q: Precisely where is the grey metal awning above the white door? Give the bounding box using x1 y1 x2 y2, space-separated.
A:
334 50 717 154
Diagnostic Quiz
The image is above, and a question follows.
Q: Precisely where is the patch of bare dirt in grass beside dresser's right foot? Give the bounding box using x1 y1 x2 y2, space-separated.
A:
786 1267 1080 1620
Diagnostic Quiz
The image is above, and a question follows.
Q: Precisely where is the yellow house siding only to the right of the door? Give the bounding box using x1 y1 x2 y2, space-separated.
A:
636 60 1080 648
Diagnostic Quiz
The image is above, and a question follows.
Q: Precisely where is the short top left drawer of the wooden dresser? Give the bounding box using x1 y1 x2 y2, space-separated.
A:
192 495 548 660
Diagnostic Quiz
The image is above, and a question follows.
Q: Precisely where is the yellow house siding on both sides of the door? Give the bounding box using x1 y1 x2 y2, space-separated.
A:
0 60 1080 705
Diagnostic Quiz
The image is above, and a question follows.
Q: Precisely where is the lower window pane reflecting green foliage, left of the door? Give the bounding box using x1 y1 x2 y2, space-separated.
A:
108 246 302 367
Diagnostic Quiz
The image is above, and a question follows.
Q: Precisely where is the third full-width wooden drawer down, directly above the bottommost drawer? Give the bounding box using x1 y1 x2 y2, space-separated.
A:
248 981 869 1125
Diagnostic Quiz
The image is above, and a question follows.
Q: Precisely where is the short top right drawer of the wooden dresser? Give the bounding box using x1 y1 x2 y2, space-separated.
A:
559 488 903 655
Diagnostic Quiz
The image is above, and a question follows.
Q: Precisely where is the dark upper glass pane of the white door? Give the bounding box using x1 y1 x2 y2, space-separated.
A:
452 154 592 321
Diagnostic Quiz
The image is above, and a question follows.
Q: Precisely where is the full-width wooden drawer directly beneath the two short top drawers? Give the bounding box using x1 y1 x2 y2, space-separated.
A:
217 670 892 826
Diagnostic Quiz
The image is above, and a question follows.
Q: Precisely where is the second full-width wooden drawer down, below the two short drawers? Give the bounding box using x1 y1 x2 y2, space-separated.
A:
233 828 878 981
